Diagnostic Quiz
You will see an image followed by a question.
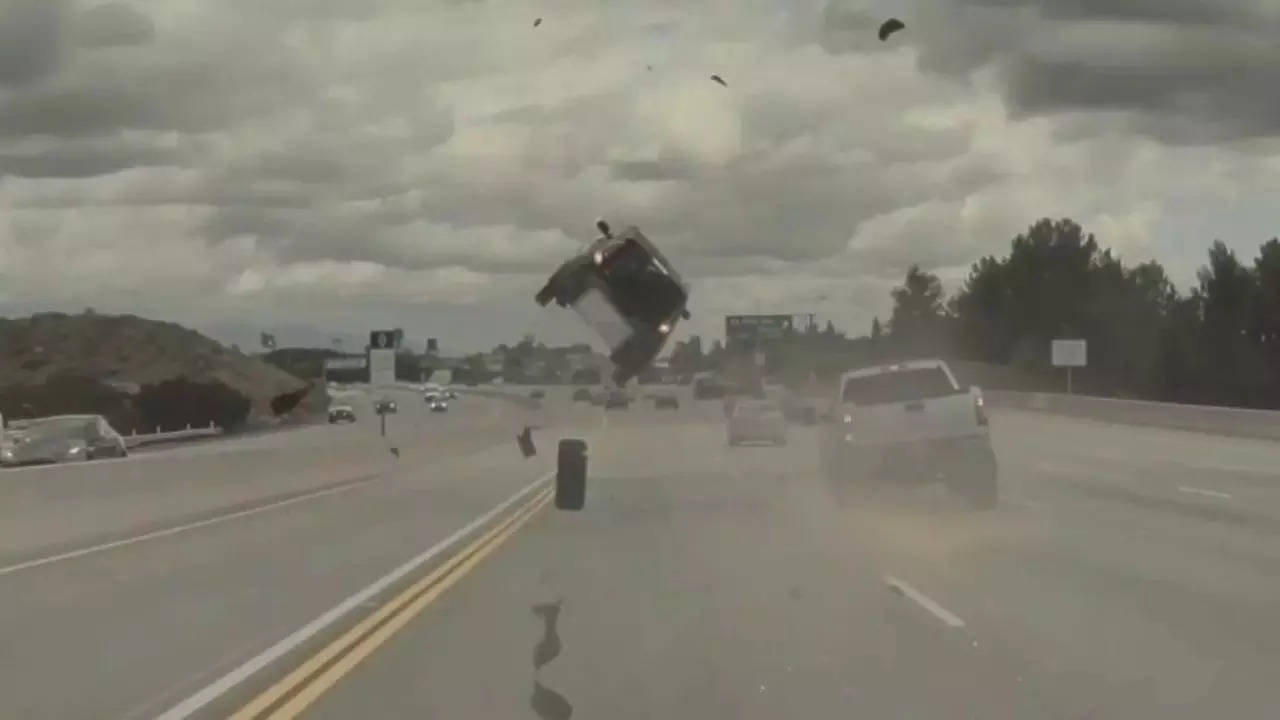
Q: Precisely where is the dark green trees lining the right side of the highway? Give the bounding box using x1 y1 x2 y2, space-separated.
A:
672 218 1280 407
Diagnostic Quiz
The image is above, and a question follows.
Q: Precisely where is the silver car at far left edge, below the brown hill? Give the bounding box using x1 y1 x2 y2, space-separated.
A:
0 415 129 465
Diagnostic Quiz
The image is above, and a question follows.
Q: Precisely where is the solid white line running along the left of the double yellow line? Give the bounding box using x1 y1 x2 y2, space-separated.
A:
149 471 554 720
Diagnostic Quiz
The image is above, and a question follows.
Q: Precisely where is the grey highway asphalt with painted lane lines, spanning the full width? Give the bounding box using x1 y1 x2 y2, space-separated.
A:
0 389 1280 720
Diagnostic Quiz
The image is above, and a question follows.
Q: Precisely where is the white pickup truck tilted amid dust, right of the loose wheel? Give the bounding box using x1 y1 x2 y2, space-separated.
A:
819 360 997 509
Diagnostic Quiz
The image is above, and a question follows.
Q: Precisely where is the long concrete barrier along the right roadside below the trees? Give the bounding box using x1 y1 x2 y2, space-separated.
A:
983 391 1280 441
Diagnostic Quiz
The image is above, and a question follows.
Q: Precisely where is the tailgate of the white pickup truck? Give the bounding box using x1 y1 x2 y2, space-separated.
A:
841 392 982 445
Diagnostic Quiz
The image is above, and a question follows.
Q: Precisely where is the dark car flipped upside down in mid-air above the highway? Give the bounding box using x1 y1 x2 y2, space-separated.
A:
535 220 689 386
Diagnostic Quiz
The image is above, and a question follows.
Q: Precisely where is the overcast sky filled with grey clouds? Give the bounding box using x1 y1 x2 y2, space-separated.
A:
0 0 1280 351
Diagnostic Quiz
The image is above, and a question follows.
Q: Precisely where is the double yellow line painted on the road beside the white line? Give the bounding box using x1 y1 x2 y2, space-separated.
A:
232 488 552 720
